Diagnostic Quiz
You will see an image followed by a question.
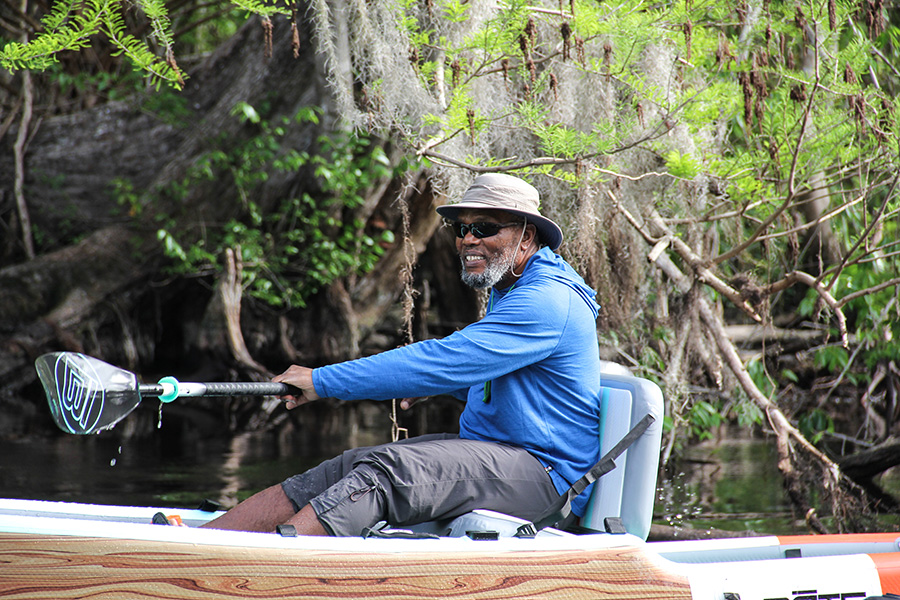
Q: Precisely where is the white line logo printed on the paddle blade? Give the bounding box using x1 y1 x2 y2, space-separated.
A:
54 354 106 433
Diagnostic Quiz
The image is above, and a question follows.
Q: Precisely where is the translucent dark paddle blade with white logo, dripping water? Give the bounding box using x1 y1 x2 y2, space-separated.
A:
34 352 141 434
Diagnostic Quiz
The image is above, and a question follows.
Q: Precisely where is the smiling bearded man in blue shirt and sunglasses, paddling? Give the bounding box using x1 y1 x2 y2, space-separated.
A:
200 174 600 536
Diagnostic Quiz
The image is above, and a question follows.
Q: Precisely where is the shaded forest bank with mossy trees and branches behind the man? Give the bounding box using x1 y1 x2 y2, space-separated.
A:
0 1 900 530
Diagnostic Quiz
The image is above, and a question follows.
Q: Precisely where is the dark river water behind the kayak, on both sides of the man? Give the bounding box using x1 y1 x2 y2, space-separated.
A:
0 420 900 533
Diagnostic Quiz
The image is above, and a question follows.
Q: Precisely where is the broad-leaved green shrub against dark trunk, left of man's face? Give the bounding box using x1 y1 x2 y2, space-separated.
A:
157 102 409 308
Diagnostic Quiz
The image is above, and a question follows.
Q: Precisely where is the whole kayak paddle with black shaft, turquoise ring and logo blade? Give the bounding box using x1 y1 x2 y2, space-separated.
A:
34 352 298 434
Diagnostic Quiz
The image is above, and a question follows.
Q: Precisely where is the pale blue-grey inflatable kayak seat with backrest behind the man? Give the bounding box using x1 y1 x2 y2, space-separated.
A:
411 368 664 540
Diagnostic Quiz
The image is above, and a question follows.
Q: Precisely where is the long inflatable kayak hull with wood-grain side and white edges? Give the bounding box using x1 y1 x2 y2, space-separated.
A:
0 500 900 600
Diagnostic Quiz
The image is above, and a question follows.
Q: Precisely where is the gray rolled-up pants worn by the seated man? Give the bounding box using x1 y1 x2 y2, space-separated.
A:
281 434 559 536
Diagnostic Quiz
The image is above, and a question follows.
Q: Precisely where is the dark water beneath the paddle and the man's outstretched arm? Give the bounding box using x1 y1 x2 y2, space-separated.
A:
0 401 459 508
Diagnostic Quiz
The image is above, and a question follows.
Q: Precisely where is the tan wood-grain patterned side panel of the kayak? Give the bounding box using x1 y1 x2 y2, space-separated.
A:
0 533 691 600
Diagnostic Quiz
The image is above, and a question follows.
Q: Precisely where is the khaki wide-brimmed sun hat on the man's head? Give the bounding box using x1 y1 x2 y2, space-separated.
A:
436 173 563 250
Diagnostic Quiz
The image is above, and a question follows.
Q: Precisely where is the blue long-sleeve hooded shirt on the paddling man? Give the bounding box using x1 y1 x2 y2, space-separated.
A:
313 248 600 515
